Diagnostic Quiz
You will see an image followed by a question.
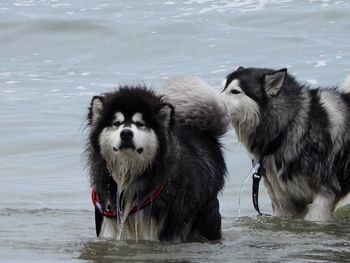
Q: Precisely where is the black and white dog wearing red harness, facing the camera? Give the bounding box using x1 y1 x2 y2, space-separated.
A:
86 77 230 241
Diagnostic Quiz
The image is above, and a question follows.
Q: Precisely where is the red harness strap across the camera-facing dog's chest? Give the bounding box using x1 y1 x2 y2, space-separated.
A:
91 184 165 217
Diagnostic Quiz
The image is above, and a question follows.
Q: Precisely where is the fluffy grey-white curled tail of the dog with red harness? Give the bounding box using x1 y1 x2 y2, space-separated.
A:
159 76 230 136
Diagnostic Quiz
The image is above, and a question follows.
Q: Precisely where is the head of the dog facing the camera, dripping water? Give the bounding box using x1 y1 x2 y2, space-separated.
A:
88 86 174 191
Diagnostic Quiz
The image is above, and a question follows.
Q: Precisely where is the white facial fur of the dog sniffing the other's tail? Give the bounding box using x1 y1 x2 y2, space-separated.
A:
221 79 260 146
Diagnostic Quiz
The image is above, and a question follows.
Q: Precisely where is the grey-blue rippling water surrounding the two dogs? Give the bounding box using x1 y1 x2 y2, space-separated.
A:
0 0 350 262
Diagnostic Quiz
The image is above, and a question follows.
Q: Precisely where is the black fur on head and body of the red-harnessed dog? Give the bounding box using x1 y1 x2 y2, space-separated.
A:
86 86 226 241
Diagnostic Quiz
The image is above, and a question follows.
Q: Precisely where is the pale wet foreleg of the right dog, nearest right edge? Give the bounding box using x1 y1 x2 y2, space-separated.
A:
305 193 335 221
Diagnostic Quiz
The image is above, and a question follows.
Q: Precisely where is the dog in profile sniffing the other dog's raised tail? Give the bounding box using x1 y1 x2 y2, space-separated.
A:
222 67 350 221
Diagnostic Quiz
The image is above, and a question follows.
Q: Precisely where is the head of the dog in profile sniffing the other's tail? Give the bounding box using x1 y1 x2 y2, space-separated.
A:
222 67 287 144
